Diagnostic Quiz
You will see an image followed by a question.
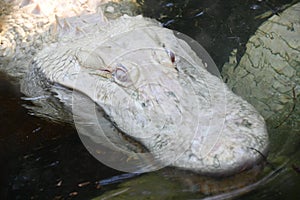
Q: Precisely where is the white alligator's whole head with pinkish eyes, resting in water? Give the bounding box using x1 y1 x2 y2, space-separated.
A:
21 16 268 175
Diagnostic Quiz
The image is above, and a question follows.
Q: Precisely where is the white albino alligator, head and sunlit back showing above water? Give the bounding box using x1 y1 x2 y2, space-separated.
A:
0 0 268 175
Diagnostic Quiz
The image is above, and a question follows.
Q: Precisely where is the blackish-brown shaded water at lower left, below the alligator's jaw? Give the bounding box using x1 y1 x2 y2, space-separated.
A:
0 74 120 199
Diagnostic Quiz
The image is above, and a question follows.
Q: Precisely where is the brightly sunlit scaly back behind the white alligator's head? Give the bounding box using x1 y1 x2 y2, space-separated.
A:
0 0 112 77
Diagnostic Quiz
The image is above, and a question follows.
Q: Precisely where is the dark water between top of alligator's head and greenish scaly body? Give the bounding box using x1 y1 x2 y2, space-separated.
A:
142 0 293 69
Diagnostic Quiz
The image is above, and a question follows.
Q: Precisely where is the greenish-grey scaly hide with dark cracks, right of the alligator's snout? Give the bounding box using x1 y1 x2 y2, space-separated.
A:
222 3 300 129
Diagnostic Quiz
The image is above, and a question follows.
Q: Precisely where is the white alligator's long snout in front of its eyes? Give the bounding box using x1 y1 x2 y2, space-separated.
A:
67 54 268 176
